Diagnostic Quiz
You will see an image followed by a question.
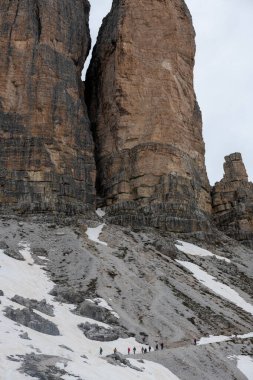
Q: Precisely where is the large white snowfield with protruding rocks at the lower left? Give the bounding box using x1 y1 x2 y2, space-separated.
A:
0 242 178 380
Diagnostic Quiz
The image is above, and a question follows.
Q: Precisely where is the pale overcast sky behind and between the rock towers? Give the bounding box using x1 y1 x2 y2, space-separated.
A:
83 0 253 184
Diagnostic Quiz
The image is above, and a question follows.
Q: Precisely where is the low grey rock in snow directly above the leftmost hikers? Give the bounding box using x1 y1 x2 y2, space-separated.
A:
78 322 120 342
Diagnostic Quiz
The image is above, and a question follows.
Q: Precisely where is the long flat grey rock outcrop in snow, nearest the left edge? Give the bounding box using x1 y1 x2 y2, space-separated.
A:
4 307 60 336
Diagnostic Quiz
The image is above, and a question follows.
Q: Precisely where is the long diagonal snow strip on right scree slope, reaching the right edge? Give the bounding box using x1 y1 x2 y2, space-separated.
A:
176 260 253 315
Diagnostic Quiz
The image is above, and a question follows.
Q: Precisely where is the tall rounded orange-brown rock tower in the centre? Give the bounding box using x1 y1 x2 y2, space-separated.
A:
86 0 211 231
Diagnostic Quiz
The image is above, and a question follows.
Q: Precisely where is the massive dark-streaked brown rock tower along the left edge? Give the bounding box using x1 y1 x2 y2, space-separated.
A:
0 0 95 214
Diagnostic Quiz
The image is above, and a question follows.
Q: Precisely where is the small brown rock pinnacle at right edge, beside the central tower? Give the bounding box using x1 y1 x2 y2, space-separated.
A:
212 153 253 247
